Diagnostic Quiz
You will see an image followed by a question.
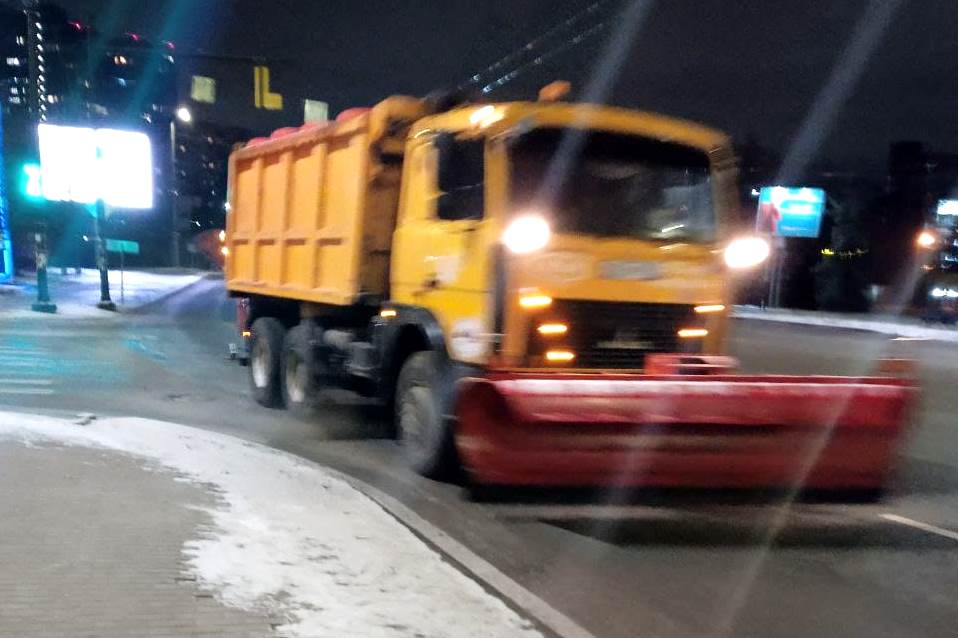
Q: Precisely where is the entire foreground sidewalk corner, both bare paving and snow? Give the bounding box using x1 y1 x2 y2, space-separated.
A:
0 412 540 638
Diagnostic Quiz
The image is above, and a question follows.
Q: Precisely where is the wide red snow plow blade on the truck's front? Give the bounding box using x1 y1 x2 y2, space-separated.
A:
456 362 917 490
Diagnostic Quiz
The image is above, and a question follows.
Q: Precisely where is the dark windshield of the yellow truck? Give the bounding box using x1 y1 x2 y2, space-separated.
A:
511 129 715 242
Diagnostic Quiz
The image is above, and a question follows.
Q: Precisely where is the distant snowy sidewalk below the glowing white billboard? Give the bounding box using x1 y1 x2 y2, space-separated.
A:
0 268 208 318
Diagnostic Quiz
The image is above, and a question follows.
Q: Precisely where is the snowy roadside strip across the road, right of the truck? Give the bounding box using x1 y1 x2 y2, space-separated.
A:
732 306 958 343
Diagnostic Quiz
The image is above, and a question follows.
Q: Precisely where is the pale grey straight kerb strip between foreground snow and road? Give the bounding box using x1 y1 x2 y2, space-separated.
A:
334 466 596 638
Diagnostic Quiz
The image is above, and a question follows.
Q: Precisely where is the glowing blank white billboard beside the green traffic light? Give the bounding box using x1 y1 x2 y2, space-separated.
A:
37 124 153 209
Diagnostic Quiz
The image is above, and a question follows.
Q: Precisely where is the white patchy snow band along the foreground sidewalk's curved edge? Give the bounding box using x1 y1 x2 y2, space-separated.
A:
0 412 540 638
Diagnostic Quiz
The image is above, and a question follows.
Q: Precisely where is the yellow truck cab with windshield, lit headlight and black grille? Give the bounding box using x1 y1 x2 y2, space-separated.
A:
391 103 736 372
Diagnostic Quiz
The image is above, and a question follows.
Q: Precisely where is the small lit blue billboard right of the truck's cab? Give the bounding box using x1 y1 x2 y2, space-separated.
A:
756 186 825 238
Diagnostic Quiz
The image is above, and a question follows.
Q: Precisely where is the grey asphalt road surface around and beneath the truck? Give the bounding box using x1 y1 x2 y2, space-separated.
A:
0 280 958 638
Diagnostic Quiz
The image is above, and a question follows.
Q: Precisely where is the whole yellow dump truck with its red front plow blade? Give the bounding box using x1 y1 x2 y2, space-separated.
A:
226 92 910 487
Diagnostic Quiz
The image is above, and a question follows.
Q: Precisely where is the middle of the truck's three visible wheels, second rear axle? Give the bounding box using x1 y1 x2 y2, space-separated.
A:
281 324 326 420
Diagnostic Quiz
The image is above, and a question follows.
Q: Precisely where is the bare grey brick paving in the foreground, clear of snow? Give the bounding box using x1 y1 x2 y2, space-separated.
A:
0 441 275 638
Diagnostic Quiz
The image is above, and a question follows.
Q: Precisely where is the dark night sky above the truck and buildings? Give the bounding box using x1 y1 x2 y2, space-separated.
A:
50 0 958 175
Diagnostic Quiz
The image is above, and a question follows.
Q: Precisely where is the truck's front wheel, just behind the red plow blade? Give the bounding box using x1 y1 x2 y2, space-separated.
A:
395 352 455 478
